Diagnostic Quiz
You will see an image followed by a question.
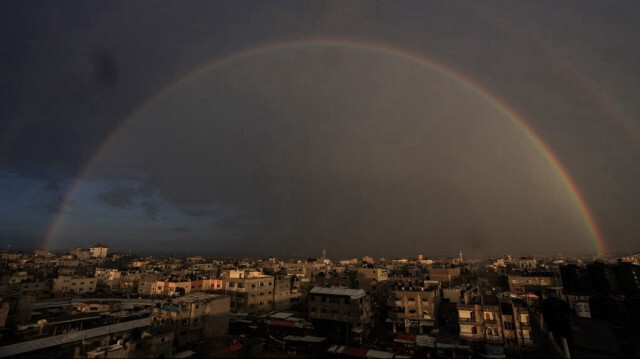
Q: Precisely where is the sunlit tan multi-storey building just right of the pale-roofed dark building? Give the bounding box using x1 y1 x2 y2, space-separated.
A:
387 280 441 334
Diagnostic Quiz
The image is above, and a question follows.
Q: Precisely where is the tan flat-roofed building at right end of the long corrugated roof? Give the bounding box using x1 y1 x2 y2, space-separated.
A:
151 293 230 347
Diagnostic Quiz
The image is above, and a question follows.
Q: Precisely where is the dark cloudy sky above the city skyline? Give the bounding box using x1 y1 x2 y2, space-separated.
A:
0 1 640 257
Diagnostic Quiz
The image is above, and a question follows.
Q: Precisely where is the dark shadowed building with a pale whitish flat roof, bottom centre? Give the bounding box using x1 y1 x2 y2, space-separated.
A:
309 287 372 344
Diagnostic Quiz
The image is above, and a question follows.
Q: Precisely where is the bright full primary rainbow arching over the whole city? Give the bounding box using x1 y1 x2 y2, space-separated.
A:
43 39 608 255
